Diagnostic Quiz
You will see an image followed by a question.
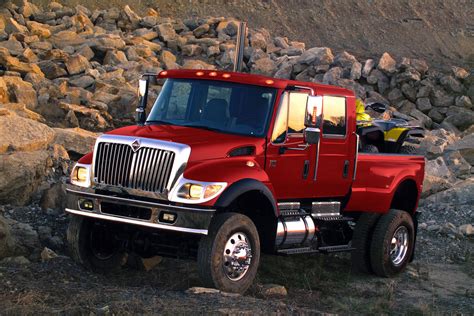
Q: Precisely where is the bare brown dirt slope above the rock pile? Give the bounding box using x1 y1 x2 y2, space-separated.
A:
4 0 474 68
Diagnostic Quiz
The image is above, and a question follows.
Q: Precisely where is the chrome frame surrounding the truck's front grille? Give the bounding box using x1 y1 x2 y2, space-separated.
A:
91 134 191 199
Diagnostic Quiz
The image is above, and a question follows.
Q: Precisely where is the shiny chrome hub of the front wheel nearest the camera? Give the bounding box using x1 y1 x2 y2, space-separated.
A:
223 232 252 281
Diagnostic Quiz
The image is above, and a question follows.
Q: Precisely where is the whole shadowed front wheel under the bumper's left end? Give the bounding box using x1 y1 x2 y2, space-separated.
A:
67 215 127 273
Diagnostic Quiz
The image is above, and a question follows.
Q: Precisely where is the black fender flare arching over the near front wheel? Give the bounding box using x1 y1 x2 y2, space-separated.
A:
222 190 277 252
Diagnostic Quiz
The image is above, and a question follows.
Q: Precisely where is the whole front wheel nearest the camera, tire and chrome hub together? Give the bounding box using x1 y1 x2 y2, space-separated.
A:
198 213 260 293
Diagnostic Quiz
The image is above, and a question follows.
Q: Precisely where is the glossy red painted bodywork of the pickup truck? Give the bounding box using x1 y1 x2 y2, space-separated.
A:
80 70 424 213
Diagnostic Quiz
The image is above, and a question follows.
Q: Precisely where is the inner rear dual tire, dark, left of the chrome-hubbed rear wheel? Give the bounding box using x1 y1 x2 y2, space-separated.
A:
351 213 380 273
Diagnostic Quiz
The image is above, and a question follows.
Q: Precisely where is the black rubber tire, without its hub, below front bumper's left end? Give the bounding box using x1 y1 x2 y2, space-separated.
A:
67 215 127 273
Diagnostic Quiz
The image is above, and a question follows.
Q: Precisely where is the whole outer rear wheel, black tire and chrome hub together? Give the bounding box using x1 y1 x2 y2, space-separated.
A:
370 210 415 277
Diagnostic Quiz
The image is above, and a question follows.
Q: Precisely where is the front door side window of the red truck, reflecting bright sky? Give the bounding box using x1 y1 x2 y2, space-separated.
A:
272 92 308 144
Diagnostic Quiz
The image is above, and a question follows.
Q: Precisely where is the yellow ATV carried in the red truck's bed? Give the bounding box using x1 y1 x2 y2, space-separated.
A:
356 99 425 155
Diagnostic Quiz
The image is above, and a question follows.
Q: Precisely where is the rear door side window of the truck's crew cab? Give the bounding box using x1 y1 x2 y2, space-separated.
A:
323 96 346 136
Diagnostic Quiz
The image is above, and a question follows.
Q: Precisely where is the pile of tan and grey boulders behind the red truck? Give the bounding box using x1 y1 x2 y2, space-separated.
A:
0 2 474 311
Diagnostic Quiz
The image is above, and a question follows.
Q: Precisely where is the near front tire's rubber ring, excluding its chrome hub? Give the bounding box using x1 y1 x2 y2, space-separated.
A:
197 213 260 293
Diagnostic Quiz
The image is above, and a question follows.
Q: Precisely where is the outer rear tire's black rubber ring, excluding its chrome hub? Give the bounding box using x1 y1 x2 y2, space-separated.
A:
370 209 415 277
